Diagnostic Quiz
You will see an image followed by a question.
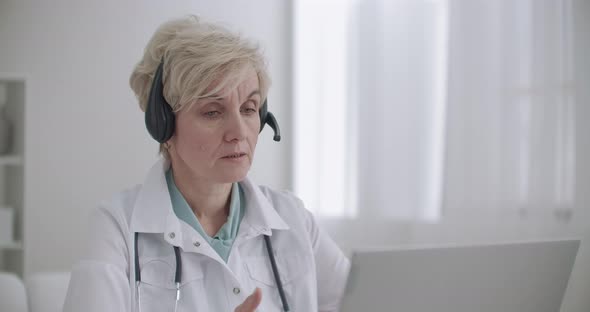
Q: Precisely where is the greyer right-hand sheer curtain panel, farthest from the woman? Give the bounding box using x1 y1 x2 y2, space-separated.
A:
445 0 575 216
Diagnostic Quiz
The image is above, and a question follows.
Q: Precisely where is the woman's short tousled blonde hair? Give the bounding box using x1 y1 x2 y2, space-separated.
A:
129 15 271 158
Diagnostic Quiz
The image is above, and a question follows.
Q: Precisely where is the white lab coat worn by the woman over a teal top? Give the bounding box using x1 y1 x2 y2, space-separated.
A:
64 159 350 312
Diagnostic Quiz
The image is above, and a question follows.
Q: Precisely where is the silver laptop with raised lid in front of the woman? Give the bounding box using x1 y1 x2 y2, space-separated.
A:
341 240 580 312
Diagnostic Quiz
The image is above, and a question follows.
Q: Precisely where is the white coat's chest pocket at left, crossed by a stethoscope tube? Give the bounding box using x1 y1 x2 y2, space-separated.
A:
140 257 208 312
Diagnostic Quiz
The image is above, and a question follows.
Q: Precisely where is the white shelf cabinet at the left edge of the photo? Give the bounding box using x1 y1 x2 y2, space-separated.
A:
0 73 26 276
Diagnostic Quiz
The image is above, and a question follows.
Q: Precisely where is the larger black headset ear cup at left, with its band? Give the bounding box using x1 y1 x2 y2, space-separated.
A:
145 62 175 143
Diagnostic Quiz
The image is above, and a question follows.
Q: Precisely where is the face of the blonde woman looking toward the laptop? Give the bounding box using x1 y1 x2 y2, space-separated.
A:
169 67 262 183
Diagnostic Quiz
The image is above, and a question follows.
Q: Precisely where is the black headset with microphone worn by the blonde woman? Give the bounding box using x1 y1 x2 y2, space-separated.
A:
145 58 281 143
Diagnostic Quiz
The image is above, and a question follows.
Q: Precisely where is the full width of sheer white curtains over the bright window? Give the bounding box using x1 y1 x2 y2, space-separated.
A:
294 0 575 222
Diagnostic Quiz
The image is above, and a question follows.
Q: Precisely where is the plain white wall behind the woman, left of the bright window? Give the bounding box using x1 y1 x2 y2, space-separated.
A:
0 0 291 275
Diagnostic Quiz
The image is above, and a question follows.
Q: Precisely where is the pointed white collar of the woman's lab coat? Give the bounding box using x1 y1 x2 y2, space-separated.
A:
130 158 289 235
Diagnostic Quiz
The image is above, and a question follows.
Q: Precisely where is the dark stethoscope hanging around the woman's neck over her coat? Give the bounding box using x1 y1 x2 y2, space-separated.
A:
134 232 289 312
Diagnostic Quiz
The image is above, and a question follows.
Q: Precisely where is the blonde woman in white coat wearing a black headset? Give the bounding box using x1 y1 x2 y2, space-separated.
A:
64 16 349 312
